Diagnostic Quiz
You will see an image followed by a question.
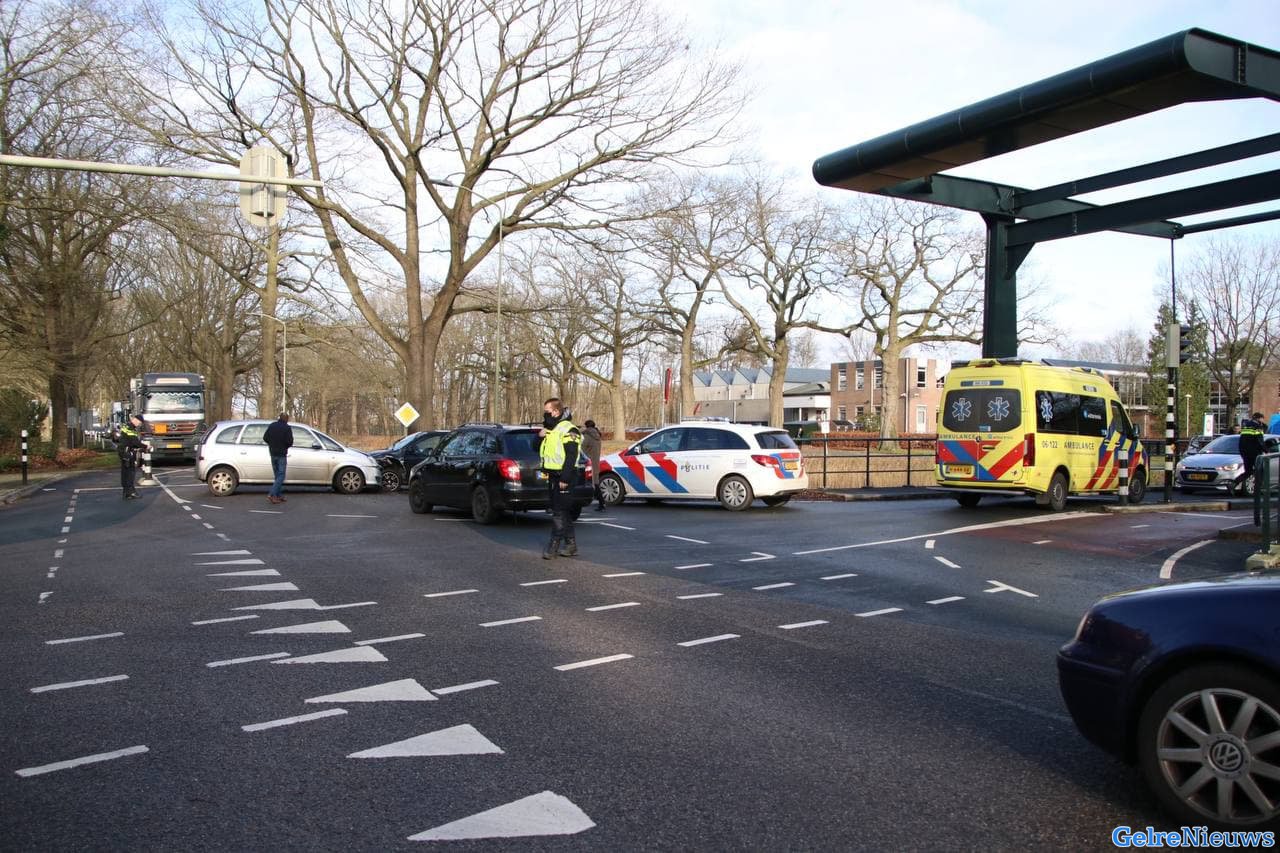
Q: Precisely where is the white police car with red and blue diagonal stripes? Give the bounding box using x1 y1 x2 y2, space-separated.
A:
599 420 809 511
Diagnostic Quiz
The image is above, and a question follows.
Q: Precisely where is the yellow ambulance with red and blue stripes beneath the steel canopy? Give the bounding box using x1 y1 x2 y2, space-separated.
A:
934 359 1147 512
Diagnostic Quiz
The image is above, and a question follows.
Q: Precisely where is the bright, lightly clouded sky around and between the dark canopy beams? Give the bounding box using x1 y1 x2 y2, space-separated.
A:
667 0 1280 356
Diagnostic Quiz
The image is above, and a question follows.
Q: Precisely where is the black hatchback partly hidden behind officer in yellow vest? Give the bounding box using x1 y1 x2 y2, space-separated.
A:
408 424 593 524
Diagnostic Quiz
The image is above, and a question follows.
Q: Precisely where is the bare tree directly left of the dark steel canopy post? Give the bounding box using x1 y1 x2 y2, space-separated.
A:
841 199 982 437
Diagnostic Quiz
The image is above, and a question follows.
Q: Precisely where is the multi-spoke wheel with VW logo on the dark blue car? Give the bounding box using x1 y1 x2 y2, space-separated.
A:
1138 663 1280 827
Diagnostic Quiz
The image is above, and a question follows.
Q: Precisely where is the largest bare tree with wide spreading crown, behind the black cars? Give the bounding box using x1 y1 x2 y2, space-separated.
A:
142 0 739 425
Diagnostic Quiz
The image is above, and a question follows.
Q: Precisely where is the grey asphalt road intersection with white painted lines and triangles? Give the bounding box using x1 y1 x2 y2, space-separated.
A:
0 469 1251 850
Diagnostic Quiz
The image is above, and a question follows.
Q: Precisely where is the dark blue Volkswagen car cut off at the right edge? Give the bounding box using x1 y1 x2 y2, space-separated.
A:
1057 574 1280 829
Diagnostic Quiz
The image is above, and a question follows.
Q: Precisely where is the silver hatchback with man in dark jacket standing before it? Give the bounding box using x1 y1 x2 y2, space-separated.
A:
196 420 381 497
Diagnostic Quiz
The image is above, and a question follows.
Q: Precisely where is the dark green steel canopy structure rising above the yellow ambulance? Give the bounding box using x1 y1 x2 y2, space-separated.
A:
813 29 1280 357
